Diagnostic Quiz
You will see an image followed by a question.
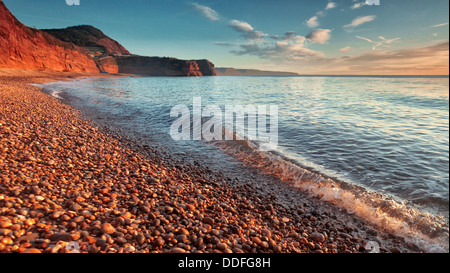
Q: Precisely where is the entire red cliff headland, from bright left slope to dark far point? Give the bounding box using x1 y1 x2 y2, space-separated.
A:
0 0 217 76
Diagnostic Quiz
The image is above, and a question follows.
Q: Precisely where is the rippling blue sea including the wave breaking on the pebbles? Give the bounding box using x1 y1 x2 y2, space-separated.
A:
40 76 449 252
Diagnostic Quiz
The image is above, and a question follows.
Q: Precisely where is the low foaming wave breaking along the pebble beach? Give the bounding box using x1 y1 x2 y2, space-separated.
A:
214 128 449 252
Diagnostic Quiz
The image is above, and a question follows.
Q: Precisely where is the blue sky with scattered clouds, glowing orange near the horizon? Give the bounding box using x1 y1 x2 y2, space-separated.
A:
3 0 449 75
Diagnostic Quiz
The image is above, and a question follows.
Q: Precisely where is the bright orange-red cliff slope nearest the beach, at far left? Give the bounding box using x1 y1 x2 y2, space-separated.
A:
0 0 99 72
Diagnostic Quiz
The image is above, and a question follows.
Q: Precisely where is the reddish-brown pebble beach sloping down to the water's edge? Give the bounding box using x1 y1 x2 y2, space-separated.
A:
0 70 420 253
